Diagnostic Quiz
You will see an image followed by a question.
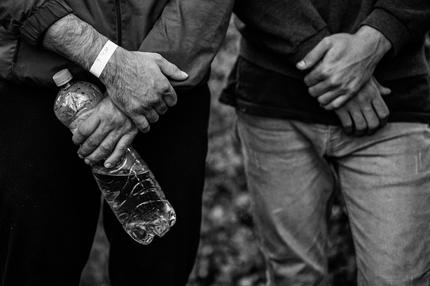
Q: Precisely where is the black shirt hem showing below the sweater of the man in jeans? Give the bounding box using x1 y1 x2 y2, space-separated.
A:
221 57 430 125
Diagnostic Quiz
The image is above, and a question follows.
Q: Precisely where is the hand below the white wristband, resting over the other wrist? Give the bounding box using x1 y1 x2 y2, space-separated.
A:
100 48 188 132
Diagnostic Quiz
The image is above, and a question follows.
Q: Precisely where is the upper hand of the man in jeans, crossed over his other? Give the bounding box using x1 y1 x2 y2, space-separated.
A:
297 26 391 110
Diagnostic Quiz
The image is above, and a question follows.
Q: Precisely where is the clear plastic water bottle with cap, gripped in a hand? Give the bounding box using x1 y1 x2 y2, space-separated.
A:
53 69 176 245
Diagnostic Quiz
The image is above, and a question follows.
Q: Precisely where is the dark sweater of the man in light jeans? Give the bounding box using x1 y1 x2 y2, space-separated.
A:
235 0 430 80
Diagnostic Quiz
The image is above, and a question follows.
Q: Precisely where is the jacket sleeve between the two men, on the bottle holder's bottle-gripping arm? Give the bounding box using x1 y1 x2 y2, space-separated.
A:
139 0 234 88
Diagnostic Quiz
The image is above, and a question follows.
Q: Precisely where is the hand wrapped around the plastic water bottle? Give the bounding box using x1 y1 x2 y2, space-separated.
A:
73 97 137 168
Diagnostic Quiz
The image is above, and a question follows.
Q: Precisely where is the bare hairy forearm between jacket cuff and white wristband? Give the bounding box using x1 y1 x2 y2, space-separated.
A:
43 14 108 70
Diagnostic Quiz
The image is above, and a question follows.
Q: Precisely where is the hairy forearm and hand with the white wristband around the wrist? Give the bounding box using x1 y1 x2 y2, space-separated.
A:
43 15 188 132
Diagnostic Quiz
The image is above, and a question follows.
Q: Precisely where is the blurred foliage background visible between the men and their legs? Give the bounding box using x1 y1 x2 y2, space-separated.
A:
81 22 430 286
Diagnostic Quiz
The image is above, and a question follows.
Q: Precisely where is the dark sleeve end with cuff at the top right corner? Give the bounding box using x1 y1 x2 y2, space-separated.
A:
362 0 430 54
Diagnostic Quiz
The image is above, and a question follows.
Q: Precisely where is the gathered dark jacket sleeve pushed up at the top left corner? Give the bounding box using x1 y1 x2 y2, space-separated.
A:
0 0 72 45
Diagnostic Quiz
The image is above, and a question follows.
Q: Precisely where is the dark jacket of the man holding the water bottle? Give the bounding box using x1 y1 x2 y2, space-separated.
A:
0 0 233 87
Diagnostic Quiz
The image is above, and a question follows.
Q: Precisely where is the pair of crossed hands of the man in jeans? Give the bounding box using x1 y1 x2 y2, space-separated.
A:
297 26 391 135
